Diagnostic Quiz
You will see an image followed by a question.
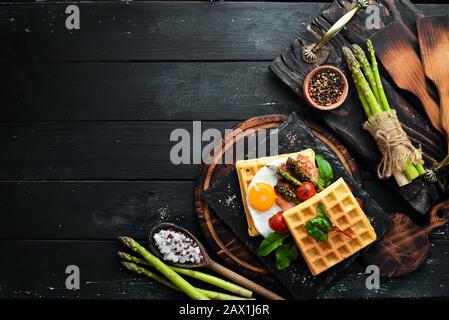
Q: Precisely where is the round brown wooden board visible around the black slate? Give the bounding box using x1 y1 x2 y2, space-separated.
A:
195 115 361 281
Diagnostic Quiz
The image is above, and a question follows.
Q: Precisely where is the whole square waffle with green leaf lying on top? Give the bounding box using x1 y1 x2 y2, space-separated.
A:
283 178 376 276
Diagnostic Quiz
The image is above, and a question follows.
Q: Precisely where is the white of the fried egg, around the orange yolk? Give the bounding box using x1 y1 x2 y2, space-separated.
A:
246 158 287 238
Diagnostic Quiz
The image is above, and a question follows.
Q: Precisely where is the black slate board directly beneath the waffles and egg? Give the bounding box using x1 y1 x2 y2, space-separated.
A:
202 113 390 299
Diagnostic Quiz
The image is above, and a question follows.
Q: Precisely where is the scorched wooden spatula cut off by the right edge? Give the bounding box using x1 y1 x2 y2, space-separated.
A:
417 16 449 150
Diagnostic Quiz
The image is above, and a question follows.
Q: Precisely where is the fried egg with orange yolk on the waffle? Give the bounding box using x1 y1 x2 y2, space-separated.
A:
246 158 287 237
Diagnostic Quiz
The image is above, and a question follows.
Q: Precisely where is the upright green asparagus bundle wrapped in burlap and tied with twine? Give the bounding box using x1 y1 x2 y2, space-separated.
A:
343 39 425 187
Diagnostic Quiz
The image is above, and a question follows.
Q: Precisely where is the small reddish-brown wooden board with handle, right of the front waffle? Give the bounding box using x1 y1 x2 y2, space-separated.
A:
363 200 449 278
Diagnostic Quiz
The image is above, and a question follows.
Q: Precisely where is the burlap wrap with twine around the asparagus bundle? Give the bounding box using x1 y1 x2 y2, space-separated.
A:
363 109 424 179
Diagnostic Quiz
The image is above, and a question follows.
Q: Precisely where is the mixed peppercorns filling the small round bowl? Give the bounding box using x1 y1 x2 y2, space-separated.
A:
309 69 344 107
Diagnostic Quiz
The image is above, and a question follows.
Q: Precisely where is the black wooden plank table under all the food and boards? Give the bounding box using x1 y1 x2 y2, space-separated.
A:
0 1 449 299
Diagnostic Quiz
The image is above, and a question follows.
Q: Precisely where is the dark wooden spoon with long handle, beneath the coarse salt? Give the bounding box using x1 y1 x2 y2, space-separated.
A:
149 223 285 300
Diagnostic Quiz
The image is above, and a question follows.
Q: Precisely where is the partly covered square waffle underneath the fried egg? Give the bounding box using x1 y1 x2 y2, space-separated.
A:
235 149 315 237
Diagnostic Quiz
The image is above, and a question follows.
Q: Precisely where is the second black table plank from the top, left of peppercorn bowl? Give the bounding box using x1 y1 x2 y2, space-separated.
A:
0 62 309 121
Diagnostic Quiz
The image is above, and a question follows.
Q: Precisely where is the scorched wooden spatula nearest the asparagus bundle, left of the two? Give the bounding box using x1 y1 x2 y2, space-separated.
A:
371 22 443 133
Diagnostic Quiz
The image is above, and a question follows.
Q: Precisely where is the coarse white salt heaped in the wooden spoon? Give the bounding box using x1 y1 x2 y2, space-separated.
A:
153 229 203 263
